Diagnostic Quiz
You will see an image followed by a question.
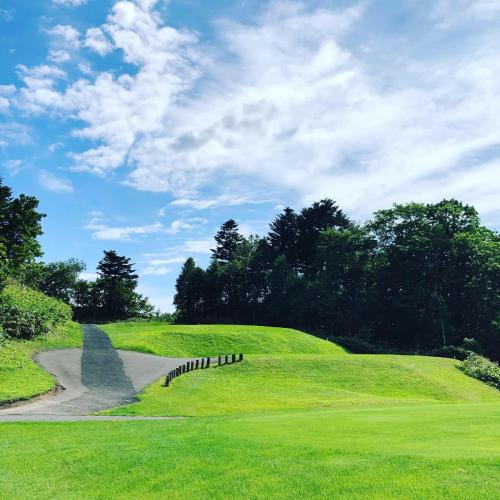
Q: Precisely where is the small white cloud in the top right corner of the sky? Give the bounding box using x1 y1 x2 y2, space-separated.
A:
431 0 500 29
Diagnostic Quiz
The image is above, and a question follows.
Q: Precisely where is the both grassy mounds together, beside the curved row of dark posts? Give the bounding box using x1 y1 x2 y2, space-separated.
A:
104 323 500 416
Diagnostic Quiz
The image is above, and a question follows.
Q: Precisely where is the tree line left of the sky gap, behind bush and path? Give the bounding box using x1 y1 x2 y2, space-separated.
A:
0 178 156 322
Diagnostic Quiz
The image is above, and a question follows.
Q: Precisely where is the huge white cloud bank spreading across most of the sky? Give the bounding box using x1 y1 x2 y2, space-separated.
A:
11 0 500 217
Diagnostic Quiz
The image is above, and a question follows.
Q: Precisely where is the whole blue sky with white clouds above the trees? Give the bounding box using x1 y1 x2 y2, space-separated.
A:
0 0 500 310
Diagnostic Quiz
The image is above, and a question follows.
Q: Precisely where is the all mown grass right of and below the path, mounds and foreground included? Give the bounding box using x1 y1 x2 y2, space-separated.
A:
0 323 500 499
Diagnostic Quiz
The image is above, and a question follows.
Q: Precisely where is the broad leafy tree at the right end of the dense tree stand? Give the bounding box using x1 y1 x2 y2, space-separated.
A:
368 200 500 348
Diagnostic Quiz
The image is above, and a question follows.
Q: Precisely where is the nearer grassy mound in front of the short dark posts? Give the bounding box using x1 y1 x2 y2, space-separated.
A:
105 354 500 416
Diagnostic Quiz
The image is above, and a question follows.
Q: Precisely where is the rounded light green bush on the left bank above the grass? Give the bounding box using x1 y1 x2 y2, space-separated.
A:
0 283 72 339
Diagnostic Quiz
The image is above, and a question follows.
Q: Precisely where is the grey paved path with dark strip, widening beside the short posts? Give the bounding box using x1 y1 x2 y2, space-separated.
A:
0 325 191 422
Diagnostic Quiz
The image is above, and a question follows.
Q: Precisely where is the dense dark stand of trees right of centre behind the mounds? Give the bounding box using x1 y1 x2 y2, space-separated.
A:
175 199 500 359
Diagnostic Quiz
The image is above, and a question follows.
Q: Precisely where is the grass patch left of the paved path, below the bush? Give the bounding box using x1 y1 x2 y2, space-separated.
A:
0 322 82 404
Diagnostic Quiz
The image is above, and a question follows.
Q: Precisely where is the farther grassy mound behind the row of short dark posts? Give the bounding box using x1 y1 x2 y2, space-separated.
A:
100 323 345 357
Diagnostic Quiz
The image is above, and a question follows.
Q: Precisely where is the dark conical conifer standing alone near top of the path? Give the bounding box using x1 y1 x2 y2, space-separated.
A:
95 250 143 320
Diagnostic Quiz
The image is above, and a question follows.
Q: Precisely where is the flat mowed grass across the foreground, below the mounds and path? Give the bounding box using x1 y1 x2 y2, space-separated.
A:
0 403 500 499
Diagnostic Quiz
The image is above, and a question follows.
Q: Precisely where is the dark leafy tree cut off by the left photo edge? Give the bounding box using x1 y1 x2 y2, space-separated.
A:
0 177 45 275
